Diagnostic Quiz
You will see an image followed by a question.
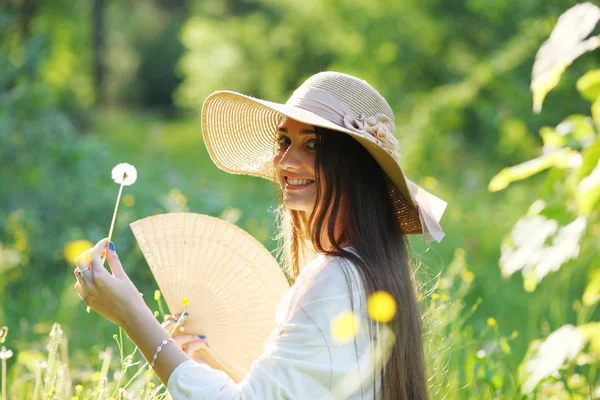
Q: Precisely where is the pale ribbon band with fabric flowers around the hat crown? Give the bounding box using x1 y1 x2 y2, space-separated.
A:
286 87 400 161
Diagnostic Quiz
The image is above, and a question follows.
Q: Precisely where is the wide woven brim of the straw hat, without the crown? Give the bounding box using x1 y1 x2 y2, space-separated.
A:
202 90 445 240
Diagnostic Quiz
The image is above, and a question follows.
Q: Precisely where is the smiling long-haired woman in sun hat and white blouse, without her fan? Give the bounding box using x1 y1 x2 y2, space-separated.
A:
75 72 446 400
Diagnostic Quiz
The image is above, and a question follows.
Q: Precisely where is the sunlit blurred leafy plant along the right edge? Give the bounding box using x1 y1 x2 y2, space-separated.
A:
488 3 600 398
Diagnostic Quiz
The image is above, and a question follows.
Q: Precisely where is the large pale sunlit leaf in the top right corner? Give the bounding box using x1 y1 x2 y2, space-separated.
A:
530 2 600 113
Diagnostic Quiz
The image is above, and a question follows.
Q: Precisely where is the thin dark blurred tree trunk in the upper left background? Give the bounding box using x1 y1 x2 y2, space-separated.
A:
92 0 106 105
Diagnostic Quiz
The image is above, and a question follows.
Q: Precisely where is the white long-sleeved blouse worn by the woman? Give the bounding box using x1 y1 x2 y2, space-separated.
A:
167 255 380 400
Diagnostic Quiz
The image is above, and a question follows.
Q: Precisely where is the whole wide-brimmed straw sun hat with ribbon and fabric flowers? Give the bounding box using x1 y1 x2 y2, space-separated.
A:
202 72 446 242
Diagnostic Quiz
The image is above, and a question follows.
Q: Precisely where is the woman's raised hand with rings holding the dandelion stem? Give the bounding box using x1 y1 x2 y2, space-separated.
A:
74 238 148 326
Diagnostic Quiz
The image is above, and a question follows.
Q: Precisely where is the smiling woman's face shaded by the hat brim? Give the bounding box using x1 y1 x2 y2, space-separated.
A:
273 118 317 213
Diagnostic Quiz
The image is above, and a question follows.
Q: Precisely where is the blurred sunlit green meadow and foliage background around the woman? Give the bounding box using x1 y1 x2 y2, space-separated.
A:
0 0 600 399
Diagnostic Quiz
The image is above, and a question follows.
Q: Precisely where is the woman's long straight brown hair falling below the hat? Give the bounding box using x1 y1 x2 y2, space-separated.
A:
280 127 429 400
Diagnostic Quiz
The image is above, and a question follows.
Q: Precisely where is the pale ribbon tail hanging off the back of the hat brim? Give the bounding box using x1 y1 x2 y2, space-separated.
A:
405 178 448 244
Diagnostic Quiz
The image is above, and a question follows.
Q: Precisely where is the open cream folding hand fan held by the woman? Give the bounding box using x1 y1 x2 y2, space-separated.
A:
130 213 290 382
